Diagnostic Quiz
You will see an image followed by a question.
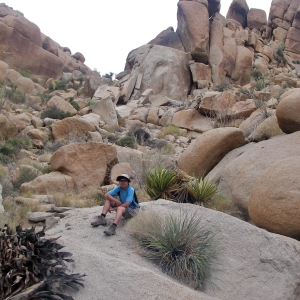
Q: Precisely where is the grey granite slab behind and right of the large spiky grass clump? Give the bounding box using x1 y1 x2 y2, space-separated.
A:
149 200 300 300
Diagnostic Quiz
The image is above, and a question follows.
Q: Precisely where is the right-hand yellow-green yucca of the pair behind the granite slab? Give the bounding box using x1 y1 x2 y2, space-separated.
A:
186 177 218 204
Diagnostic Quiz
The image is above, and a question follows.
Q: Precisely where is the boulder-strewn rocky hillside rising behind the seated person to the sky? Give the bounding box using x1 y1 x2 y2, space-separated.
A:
0 0 300 247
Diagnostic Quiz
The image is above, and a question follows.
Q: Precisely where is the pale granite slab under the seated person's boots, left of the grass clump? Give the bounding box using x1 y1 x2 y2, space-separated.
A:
46 207 220 300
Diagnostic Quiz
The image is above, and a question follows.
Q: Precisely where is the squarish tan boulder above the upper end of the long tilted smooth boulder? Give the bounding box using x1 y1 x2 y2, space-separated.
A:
172 109 213 133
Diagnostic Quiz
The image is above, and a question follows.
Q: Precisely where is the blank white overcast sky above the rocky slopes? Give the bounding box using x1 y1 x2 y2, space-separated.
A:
5 0 272 74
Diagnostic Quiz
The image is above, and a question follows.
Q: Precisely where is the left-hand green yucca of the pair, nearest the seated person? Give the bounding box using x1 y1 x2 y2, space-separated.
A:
145 167 176 199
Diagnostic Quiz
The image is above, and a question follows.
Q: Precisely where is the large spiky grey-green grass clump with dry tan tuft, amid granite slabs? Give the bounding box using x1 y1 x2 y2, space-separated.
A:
130 212 217 290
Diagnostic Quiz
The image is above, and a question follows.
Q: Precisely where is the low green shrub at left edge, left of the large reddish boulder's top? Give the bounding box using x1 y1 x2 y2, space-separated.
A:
0 138 32 163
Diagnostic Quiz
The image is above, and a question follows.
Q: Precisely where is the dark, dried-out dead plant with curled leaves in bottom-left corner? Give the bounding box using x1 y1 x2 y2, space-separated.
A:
0 225 85 300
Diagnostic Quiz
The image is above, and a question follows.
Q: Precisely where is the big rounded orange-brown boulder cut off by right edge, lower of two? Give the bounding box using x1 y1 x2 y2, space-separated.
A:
248 156 300 238
